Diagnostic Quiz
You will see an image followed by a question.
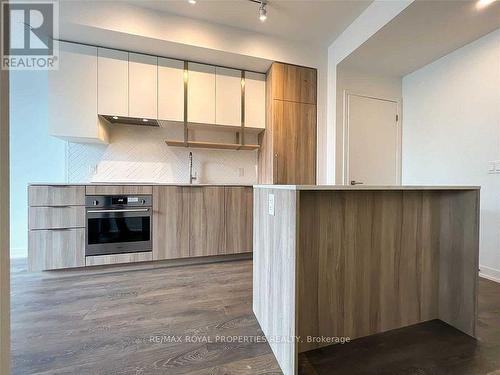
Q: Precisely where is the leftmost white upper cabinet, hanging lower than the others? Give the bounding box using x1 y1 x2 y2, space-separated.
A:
48 42 108 143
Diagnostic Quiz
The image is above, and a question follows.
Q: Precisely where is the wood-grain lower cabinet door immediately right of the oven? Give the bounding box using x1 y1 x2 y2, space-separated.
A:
153 186 191 260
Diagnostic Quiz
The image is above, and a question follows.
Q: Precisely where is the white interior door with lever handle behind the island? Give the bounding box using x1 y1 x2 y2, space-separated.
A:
344 94 401 185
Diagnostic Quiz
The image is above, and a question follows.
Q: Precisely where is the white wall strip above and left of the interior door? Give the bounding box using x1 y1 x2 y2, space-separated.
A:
335 67 402 185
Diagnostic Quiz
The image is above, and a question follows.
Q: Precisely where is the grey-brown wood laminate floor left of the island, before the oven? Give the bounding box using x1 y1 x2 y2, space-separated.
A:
11 260 281 375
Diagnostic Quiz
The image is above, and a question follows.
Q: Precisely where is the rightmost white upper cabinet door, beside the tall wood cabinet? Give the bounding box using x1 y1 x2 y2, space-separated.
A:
245 72 266 129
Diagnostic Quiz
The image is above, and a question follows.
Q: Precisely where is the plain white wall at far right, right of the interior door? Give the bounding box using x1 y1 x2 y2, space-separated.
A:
403 29 500 280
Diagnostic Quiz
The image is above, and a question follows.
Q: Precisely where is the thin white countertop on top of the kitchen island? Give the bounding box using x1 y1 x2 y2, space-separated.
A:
253 185 481 191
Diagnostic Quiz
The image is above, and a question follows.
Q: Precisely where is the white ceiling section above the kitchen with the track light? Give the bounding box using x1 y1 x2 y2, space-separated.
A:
126 0 372 45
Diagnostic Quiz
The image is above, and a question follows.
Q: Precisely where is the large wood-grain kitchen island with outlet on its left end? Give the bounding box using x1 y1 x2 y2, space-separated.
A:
253 185 479 375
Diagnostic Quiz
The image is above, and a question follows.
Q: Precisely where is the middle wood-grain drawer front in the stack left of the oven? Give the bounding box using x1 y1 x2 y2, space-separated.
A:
29 206 85 230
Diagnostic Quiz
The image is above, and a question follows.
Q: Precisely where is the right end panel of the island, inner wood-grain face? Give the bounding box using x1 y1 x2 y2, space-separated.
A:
439 191 480 336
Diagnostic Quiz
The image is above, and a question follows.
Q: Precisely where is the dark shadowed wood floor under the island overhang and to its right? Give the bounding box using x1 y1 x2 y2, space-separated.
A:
299 279 500 375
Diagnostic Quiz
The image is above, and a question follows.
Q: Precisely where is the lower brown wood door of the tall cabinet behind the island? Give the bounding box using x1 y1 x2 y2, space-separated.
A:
273 100 316 185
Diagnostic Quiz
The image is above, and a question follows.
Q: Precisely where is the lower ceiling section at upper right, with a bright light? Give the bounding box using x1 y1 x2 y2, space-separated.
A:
341 0 500 77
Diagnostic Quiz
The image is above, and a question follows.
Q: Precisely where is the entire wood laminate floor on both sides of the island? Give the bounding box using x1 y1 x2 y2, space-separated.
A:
8 260 500 375
